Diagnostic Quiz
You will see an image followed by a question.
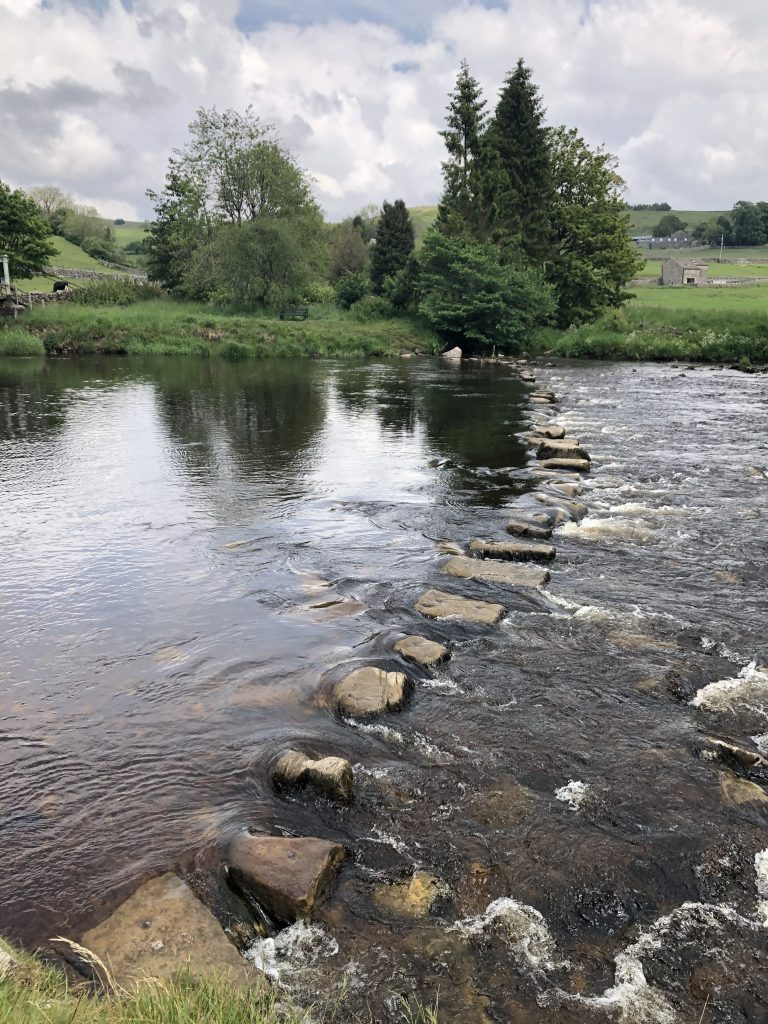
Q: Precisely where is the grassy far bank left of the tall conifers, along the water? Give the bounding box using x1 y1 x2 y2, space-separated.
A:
0 299 438 359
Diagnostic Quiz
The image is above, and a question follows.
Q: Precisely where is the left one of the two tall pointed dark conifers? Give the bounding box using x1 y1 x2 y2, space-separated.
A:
437 60 488 241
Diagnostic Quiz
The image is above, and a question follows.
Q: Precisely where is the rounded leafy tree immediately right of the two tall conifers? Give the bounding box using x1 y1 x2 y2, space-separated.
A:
546 128 643 328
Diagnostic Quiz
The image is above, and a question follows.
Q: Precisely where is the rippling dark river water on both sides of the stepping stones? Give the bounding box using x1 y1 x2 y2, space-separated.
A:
0 359 768 1024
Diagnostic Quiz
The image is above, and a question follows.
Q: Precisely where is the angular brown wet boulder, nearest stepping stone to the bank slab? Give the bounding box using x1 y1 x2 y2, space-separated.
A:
227 833 344 924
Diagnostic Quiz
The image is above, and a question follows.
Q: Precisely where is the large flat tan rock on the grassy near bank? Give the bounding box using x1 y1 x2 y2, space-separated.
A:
80 872 252 989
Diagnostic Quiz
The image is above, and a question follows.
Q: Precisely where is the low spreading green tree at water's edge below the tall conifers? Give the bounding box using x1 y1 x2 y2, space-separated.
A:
417 230 555 352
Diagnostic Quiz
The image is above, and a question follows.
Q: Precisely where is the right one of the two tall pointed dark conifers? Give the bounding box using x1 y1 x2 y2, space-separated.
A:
485 59 553 265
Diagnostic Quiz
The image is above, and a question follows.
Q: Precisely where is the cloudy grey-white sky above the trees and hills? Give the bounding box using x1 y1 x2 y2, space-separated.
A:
0 0 768 219
